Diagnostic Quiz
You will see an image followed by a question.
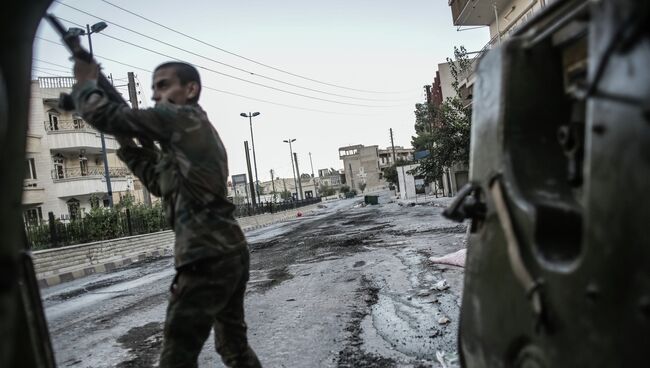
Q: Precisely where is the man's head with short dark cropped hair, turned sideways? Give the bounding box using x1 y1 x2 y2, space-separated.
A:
151 61 201 105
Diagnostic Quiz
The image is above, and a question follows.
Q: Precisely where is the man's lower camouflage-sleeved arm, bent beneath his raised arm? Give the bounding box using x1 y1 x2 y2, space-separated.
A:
117 145 162 197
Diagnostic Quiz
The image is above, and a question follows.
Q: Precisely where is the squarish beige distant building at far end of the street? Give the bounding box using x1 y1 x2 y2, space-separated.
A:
339 144 385 191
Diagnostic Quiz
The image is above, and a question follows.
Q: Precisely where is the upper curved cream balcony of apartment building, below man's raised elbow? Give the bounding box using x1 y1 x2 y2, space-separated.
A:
43 119 119 153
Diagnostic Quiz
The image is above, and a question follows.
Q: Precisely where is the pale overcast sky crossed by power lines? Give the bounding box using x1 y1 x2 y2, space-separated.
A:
32 0 489 181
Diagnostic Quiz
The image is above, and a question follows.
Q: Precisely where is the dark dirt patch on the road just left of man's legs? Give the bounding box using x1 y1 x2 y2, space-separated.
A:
117 322 163 368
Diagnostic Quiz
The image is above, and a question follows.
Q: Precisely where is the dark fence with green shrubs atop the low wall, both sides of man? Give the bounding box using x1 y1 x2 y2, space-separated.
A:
25 198 320 250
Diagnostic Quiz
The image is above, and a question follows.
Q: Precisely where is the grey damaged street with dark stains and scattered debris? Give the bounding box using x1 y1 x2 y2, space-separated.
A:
42 194 466 367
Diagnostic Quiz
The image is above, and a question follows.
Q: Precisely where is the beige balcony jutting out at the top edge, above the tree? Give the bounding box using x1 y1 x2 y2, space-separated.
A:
449 0 512 27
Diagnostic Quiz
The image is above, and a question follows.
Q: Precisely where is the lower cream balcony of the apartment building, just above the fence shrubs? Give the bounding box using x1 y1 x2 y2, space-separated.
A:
52 166 133 198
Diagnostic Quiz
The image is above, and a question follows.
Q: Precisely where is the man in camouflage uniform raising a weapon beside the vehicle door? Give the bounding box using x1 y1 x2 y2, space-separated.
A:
73 60 261 368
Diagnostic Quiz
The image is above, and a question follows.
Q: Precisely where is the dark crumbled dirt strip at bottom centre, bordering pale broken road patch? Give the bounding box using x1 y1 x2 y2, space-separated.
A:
336 277 397 368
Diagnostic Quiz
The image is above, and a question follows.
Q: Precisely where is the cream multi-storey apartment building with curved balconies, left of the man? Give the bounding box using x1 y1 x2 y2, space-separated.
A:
22 77 143 223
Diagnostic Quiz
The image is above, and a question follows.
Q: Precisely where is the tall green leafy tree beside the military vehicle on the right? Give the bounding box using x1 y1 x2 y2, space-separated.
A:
411 46 472 183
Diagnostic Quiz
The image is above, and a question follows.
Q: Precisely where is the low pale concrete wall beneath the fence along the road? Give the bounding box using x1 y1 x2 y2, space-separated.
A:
33 204 318 286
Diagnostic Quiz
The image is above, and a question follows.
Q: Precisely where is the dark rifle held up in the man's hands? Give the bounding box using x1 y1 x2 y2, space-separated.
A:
45 14 155 149
